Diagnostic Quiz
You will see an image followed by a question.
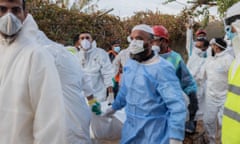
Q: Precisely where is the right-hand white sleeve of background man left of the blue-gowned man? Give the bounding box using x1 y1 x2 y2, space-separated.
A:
100 51 114 87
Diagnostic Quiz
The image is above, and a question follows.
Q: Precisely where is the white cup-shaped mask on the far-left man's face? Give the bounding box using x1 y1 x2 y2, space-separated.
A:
0 13 22 36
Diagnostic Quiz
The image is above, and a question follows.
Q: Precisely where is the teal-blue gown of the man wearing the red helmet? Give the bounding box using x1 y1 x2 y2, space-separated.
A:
160 50 197 95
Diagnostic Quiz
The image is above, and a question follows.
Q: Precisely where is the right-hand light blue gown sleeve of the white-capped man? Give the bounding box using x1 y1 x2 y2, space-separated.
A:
157 68 186 140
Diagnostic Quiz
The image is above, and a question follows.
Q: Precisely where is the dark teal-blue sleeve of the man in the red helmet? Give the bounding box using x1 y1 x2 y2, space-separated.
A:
176 60 197 95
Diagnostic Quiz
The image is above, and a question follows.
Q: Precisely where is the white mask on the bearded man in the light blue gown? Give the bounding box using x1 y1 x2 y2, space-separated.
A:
129 40 144 54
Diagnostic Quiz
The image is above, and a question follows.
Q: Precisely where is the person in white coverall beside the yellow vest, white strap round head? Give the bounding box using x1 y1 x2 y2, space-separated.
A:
199 38 234 144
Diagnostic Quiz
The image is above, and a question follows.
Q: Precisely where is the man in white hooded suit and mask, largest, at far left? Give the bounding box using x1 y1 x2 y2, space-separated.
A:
0 0 66 144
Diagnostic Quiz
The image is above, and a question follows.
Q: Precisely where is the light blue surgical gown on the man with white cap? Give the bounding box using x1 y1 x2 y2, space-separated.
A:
112 57 186 144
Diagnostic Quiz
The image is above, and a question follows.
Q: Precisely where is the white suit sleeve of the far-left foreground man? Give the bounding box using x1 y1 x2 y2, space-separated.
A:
29 48 65 144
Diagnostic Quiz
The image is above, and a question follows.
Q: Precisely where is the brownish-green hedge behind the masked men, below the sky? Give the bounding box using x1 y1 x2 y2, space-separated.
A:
28 3 188 50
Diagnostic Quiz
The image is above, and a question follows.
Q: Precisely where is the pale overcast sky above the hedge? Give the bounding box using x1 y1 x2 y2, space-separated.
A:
97 0 217 17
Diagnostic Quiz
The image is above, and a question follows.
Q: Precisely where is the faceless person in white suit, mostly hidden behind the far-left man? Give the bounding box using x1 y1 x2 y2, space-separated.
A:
23 14 93 144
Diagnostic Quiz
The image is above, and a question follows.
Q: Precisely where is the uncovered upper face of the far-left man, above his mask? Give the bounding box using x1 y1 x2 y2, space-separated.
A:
0 0 25 22
